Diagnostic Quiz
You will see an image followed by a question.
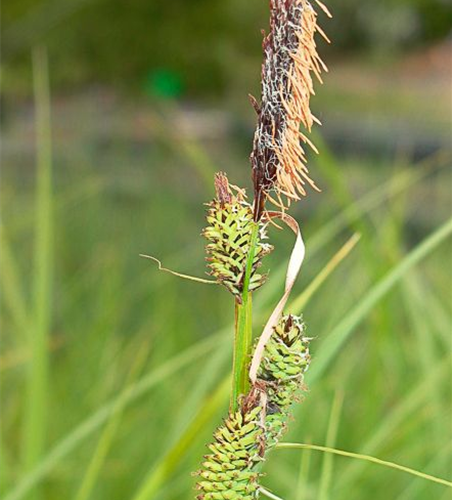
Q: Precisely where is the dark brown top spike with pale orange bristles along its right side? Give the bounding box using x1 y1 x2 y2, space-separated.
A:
251 0 328 220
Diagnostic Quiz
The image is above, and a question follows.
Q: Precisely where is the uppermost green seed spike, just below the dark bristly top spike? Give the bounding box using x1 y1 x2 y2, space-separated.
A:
203 173 273 297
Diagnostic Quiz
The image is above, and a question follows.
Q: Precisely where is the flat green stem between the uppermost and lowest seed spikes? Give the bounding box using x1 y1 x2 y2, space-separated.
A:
230 224 259 412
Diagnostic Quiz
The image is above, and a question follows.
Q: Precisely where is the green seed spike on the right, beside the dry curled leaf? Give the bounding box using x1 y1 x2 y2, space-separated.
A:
258 315 310 450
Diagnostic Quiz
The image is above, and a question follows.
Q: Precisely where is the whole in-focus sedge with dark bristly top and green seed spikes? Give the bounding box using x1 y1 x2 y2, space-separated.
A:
195 0 329 500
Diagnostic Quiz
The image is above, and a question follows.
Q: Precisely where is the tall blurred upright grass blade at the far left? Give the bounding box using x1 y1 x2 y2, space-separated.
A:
23 47 53 498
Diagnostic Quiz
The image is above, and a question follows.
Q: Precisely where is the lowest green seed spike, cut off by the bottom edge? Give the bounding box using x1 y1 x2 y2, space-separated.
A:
195 407 263 500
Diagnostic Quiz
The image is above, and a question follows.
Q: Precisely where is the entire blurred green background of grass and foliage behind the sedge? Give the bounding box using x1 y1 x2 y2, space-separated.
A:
0 0 452 500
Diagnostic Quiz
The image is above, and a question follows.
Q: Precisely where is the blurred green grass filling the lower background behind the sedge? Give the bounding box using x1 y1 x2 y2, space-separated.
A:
0 85 452 500
